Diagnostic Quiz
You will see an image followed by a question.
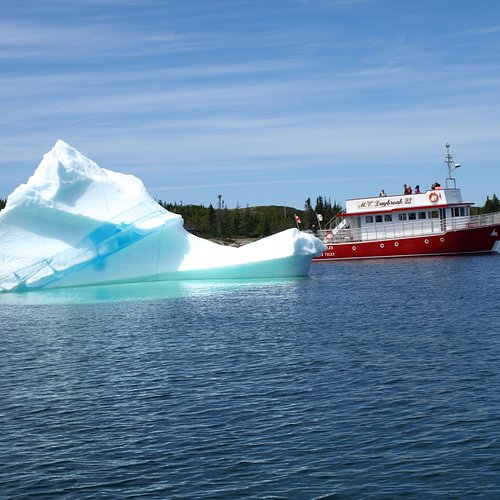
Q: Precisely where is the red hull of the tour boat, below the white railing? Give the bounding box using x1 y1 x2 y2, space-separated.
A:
313 226 500 261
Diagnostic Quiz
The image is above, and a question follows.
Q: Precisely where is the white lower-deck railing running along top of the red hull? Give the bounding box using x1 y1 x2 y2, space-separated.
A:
315 212 500 243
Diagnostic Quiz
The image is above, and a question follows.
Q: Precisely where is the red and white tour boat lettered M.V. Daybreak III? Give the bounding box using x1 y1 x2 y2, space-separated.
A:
313 144 500 261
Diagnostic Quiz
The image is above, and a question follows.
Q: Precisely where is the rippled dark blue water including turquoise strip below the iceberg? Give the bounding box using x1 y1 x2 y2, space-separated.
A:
0 255 500 499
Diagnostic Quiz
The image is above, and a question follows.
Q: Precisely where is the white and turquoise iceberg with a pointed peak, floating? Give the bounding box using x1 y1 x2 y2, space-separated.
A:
0 140 326 292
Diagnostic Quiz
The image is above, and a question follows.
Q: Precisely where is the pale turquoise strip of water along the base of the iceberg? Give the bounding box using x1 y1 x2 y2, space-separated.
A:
0 277 308 306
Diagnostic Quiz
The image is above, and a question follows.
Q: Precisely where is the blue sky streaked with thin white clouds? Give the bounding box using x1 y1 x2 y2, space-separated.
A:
0 0 500 208
